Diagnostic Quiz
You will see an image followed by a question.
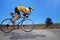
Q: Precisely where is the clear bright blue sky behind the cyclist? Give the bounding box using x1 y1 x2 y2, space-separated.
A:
0 0 60 24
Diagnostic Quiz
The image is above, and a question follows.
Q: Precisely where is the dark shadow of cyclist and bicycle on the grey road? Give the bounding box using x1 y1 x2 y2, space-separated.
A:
4 32 46 40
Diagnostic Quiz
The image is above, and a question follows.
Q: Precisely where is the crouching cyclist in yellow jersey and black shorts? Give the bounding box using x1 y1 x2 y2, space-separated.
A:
14 6 33 25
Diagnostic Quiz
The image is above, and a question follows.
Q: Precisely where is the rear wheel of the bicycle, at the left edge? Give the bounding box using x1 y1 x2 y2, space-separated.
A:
1 19 13 33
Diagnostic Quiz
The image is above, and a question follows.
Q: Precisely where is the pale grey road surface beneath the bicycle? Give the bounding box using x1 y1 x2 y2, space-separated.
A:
0 29 60 40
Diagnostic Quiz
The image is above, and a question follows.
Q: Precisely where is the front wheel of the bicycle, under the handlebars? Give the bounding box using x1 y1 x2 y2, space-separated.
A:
22 19 34 32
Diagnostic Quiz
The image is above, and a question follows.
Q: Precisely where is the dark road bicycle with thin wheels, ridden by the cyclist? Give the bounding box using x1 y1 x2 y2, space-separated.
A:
1 13 34 33
